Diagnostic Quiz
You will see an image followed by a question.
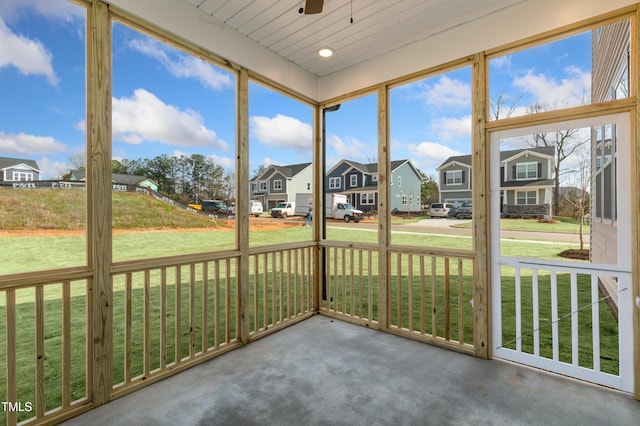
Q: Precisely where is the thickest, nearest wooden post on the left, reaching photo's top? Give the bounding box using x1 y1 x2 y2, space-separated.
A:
87 0 113 406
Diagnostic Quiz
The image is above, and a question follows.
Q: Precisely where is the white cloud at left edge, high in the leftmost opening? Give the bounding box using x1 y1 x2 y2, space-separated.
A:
0 19 59 86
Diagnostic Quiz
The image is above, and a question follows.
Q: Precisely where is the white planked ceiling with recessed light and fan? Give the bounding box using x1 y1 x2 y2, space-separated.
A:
179 0 529 77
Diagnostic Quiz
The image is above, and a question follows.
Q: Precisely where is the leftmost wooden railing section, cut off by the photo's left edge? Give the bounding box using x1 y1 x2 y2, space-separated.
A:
0 268 91 425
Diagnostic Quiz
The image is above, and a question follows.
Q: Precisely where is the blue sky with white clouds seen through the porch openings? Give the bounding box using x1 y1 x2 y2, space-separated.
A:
0 0 591 178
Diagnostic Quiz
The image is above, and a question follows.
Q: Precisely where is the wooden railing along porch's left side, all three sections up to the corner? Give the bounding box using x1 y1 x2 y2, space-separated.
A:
0 242 316 425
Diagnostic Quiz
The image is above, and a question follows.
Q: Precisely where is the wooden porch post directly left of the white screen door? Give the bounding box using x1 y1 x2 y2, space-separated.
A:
471 53 491 359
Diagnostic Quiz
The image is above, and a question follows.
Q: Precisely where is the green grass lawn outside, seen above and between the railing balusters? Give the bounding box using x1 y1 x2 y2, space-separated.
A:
0 201 618 423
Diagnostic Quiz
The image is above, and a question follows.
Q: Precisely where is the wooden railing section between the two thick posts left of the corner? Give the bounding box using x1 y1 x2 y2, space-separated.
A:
112 252 240 397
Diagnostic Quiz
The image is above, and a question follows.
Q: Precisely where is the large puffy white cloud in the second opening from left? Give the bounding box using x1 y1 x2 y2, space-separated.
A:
112 89 228 150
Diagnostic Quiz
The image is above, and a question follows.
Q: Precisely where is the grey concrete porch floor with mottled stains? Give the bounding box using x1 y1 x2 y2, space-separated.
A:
66 316 640 426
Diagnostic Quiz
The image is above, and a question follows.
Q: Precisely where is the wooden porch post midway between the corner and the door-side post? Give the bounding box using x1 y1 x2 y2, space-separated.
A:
378 85 391 330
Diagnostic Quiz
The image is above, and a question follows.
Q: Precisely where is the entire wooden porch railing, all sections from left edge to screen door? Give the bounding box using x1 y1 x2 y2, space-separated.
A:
0 242 473 425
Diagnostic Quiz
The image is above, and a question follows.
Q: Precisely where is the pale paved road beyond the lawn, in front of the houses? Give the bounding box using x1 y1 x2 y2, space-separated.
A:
327 219 588 245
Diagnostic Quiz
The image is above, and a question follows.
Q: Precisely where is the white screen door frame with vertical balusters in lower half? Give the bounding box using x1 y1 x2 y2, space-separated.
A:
489 113 634 392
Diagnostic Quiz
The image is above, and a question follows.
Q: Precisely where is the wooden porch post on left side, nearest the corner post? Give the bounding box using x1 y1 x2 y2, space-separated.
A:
236 68 250 344
